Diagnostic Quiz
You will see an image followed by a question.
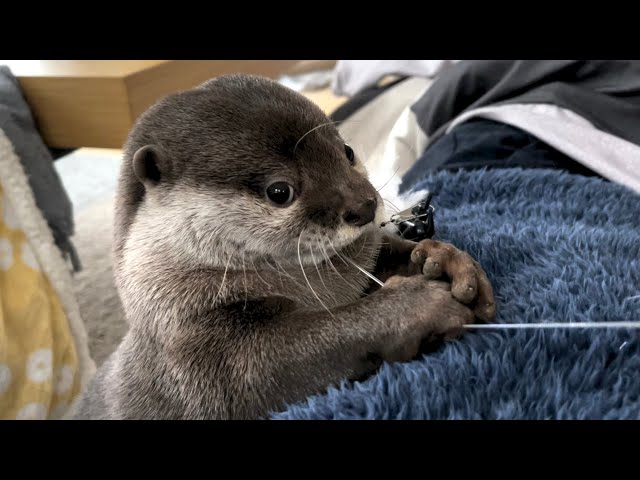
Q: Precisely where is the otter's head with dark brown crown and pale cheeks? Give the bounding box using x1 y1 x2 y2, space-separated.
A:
116 75 384 265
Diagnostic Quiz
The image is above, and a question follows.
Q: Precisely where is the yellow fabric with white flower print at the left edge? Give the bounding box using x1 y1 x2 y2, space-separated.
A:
0 186 80 420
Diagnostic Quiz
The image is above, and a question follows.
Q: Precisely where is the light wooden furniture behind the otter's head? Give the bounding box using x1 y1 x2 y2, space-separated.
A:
0 60 335 148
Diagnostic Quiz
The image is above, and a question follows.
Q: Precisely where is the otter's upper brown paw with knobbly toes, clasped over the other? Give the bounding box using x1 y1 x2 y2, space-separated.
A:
411 239 496 322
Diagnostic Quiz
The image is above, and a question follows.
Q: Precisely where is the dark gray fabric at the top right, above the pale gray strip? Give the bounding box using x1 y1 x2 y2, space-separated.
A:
411 60 640 149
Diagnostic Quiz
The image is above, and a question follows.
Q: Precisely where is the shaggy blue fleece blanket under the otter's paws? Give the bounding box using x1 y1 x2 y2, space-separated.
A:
273 168 640 419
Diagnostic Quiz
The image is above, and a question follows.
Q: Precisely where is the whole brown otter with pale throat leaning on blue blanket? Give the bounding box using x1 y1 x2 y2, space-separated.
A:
75 74 495 420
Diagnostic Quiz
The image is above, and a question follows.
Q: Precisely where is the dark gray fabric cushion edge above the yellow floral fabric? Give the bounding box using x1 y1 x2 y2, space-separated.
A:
0 65 80 270
